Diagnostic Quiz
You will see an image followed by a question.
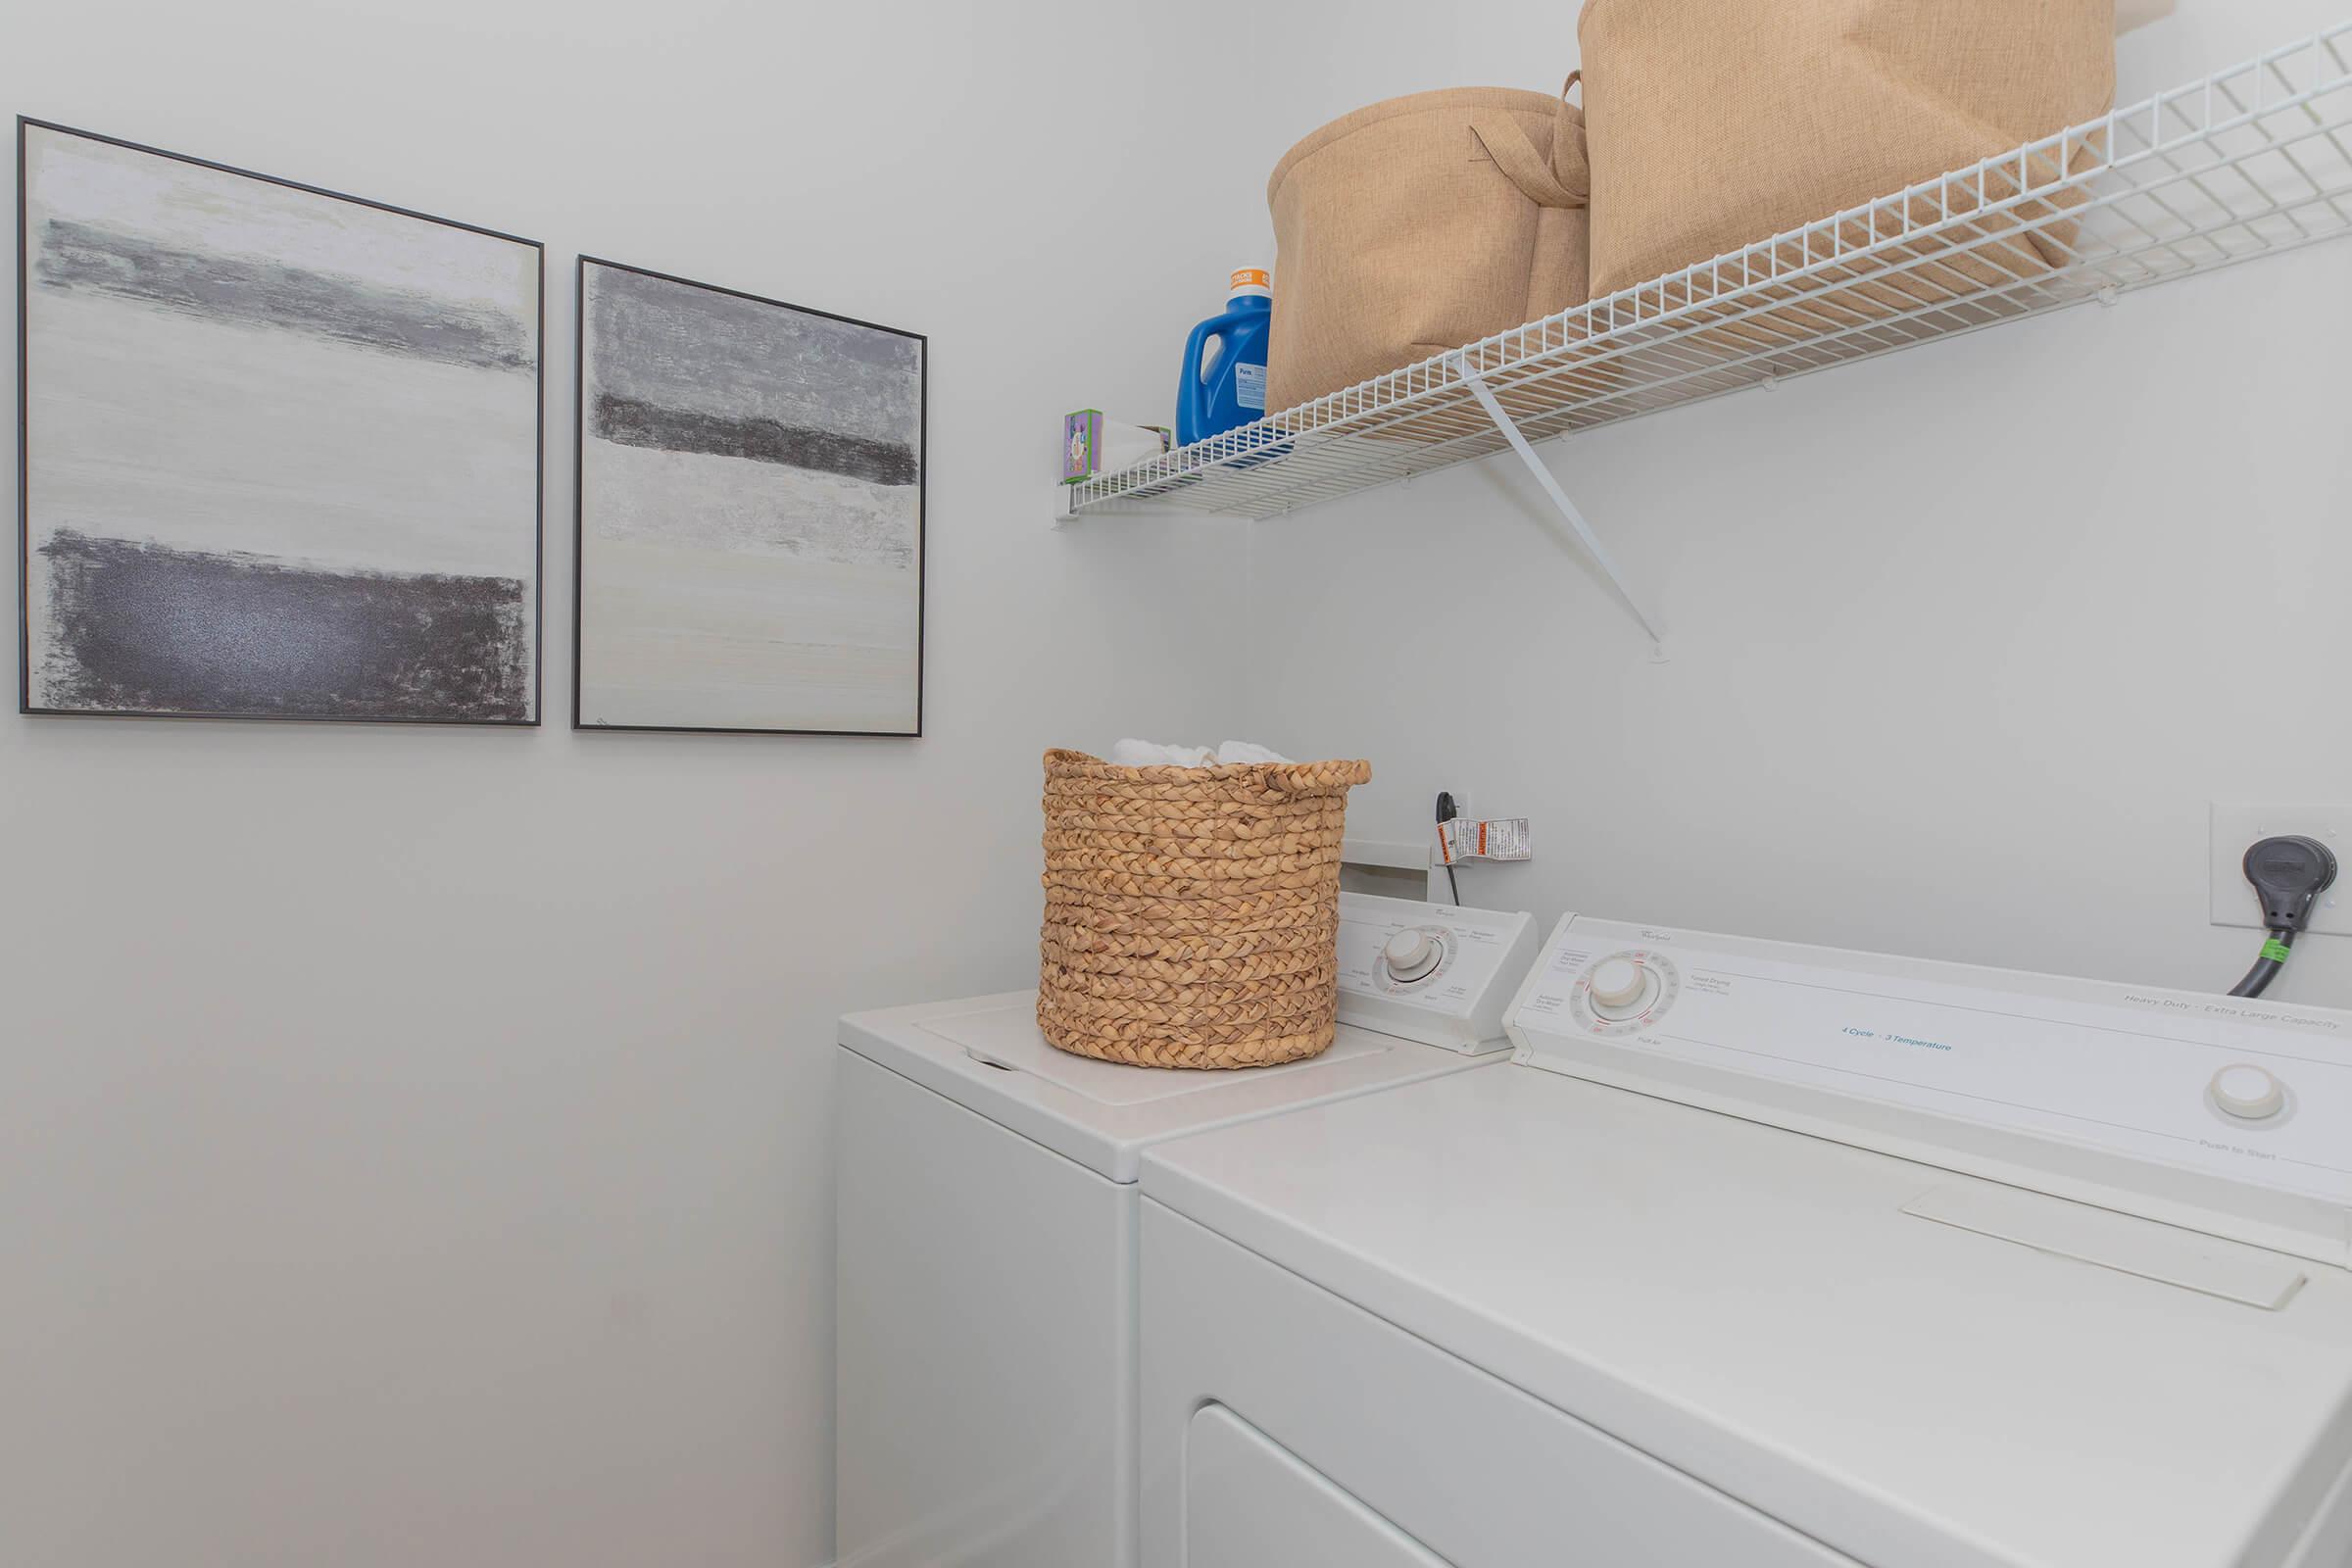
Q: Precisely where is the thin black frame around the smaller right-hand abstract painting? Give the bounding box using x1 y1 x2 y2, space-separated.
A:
571 254 931 741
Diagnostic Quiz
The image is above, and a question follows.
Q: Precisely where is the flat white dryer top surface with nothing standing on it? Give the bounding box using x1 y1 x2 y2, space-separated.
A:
1143 1065 2352 1568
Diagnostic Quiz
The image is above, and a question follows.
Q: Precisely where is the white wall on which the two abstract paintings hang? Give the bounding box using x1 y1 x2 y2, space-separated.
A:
0 0 1275 1568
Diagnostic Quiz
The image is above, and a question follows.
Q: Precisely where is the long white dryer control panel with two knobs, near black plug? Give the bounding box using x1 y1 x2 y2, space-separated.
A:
1510 914 2352 1265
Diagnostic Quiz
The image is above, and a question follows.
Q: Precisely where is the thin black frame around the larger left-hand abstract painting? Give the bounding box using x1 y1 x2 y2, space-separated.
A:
17 116 548 729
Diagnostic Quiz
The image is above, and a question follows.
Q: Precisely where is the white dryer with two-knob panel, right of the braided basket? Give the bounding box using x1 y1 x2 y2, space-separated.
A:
1143 919 2352 1568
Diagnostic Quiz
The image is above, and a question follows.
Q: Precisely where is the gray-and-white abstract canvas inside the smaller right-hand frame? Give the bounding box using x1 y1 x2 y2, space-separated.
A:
574 259 924 736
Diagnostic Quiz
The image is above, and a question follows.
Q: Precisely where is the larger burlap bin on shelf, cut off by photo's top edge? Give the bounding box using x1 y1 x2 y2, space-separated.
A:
1576 0 2115 308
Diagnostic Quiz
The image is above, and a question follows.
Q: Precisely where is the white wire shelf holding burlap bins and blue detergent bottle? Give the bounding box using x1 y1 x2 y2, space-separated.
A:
1058 22 2352 517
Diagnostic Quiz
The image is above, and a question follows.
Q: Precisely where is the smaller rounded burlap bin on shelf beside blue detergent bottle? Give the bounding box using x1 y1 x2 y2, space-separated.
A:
1265 87 1588 412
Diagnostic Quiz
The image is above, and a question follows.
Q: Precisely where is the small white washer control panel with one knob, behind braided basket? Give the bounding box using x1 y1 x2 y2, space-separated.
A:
1339 894 1539 1051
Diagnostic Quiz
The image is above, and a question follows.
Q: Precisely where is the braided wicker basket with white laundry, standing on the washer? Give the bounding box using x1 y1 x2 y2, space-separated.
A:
1037 753 1371 1067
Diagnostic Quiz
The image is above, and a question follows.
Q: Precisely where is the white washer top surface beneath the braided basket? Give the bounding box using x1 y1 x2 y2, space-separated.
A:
840 990 1503 1183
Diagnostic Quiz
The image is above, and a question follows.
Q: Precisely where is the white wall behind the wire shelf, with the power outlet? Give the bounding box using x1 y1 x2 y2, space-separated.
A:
1251 0 2352 1006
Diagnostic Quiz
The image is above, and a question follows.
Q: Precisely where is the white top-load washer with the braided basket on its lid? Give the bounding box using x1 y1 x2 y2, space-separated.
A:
835 894 1541 1568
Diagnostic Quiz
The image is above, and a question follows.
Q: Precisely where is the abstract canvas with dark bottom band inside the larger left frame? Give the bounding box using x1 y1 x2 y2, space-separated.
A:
19 122 541 724
